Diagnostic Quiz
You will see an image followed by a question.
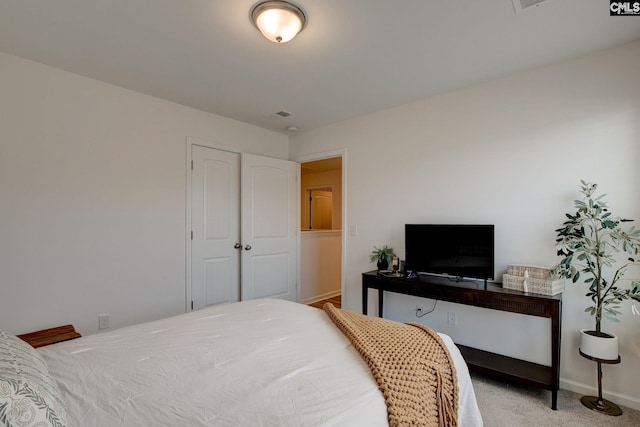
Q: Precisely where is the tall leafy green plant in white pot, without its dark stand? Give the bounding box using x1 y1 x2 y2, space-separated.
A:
555 181 640 360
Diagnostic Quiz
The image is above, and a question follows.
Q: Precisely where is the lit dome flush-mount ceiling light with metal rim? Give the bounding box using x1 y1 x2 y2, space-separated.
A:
251 0 307 43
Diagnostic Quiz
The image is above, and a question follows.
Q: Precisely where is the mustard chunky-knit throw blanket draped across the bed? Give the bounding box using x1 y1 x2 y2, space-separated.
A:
324 303 458 427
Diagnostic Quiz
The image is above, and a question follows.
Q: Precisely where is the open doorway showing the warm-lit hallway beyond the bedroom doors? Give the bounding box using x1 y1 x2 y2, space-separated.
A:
300 156 343 305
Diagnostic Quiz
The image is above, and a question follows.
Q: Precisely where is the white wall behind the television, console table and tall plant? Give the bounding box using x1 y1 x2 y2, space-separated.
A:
291 41 640 408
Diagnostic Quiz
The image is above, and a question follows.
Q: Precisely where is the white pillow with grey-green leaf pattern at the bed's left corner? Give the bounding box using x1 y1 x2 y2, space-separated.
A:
0 329 67 427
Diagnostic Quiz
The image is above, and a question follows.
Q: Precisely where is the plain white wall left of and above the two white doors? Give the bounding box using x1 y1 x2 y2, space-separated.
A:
0 53 288 334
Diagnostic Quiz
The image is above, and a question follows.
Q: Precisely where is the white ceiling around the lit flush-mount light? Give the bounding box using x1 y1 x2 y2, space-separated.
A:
0 0 640 133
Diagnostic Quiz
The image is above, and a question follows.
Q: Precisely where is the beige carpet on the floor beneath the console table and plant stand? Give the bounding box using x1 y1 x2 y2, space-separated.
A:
472 373 640 427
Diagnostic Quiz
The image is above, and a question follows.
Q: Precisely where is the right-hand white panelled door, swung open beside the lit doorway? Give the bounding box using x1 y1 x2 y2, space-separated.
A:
241 154 298 301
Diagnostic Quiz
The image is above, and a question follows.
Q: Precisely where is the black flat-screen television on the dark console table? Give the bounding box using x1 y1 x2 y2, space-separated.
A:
404 224 494 281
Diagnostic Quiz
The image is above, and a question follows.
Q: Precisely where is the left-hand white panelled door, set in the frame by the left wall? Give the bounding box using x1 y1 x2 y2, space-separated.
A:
191 145 240 310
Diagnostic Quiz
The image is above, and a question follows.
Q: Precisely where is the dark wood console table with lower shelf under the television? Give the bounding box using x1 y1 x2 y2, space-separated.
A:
362 271 562 410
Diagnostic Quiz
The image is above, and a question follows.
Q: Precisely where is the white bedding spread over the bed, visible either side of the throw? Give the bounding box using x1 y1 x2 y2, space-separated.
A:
38 300 482 427
